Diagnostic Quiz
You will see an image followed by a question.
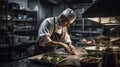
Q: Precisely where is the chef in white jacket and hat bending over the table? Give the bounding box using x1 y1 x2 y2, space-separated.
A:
35 8 76 54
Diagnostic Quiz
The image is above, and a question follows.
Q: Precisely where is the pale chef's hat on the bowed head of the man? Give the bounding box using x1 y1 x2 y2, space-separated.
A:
62 8 76 23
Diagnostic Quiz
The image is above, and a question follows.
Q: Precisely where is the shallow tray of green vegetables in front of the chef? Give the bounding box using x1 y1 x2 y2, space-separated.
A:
28 54 67 65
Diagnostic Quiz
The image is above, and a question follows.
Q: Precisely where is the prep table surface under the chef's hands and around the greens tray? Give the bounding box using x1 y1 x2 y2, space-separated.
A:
0 46 110 67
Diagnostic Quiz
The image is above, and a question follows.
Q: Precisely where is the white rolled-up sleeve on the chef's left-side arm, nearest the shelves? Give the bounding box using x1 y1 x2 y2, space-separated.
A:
38 20 51 46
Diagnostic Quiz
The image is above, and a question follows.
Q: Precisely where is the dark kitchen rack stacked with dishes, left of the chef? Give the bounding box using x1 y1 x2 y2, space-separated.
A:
0 0 37 62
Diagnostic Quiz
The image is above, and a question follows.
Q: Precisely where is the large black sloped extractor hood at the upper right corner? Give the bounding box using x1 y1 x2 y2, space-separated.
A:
82 0 120 17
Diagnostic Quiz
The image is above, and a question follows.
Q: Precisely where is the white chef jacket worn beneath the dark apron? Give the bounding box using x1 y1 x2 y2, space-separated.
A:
38 17 71 46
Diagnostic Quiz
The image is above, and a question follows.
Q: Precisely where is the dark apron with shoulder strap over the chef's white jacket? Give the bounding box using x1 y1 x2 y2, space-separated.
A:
35 17 63 54
